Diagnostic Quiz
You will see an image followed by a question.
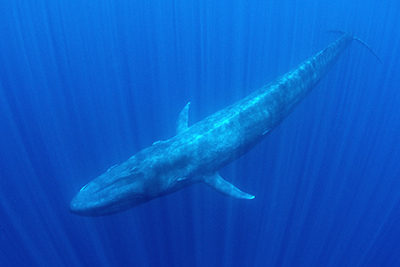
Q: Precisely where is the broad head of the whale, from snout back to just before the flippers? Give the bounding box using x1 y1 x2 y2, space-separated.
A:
69 142 193 216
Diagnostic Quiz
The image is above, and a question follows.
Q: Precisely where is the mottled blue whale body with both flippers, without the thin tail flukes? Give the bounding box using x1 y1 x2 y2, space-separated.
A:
70 33 354 216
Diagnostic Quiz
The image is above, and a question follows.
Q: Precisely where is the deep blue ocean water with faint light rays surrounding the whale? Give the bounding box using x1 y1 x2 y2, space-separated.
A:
0 0 400 266
